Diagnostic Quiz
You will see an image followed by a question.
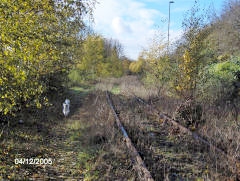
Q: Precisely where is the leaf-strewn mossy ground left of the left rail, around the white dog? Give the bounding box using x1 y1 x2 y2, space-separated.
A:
0 89 137 180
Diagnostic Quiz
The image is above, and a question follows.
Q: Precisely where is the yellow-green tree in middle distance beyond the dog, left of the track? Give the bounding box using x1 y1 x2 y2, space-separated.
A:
69 34 123 84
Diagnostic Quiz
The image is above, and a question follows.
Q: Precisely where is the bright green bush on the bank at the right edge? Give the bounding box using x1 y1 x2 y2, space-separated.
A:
198 57 240 103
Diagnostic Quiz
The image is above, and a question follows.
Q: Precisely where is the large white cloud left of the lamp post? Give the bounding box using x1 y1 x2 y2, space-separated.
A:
94 0 181 59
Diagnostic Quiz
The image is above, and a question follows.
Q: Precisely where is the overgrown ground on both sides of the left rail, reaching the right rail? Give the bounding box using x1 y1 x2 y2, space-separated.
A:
0 85 240 181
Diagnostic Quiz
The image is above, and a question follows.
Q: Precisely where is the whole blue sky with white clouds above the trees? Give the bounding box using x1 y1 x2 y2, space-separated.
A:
92 0 226 60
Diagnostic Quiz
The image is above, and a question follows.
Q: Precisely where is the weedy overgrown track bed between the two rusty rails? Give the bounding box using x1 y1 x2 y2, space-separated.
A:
106 91 239 180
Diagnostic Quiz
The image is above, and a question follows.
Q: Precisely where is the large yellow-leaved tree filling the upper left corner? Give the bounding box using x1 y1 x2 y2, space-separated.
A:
0 0 95 114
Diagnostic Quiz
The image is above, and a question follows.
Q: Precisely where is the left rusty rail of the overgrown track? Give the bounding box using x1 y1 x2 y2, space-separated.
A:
106 91 154 181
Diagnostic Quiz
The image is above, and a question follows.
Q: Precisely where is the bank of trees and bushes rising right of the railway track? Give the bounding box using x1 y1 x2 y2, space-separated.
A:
133 1 240 121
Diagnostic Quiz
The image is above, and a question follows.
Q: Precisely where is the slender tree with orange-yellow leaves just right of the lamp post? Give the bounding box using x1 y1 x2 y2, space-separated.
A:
175 2 211 96
